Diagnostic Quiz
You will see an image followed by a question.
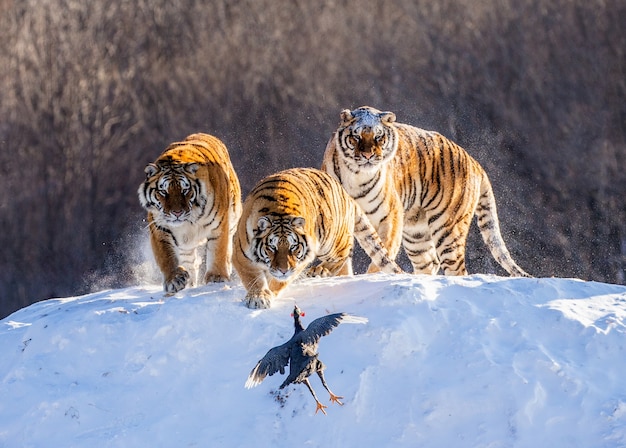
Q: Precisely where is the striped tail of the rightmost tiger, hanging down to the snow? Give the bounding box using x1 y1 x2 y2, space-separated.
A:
476 174 532 277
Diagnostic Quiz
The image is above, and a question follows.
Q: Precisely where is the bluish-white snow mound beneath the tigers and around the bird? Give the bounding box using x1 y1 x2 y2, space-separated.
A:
0 274 626 448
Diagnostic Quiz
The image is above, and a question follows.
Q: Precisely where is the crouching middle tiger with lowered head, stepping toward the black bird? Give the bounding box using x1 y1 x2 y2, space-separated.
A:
233 168 402 308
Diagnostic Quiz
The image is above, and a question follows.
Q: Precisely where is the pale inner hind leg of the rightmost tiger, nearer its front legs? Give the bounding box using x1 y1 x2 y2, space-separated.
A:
402 211 439 275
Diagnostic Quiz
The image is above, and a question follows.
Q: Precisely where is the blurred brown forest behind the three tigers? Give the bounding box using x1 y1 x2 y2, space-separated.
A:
0 0 626 317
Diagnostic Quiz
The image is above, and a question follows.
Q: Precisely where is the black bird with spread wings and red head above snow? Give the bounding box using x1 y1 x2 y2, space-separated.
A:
245 305 368 415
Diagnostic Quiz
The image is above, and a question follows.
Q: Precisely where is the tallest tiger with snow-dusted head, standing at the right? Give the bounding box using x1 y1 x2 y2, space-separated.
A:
321 106 530 277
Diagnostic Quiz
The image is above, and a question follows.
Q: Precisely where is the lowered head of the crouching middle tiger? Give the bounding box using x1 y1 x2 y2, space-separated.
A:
255 216 314 281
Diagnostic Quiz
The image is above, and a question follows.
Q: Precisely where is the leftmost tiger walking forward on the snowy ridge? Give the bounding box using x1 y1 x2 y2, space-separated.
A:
137 133 241 295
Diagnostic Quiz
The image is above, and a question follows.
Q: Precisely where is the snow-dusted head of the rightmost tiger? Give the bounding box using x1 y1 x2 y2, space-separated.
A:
336 106 398 171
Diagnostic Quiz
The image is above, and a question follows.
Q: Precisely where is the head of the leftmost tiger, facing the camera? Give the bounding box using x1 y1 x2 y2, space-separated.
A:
137 162 207 227
